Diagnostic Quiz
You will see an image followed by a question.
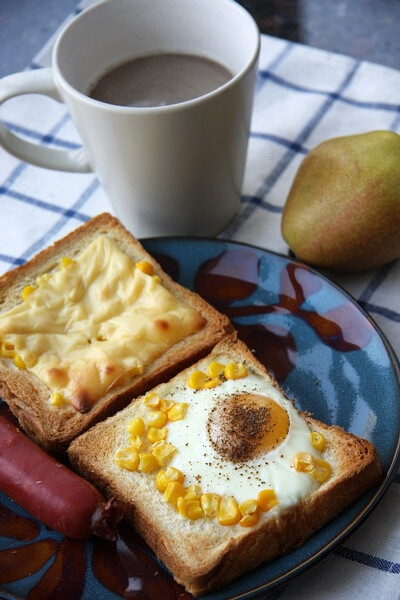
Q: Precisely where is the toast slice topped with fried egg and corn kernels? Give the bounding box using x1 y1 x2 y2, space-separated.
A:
68 335 381 596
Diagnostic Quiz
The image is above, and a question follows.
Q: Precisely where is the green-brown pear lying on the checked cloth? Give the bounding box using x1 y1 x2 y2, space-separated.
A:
282 131 400 271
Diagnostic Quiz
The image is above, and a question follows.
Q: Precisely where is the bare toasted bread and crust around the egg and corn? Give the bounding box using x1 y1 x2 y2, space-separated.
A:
68 335 381 596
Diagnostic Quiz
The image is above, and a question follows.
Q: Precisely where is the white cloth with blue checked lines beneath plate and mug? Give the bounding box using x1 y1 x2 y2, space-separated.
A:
0 0 400 600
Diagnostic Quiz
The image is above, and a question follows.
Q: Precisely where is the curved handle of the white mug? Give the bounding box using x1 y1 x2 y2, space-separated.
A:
0 68 93 173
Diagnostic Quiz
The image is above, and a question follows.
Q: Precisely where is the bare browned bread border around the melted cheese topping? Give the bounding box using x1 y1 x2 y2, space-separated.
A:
0 213 232 454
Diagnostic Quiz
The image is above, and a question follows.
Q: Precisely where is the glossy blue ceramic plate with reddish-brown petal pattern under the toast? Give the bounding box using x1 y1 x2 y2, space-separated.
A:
0 238 400 600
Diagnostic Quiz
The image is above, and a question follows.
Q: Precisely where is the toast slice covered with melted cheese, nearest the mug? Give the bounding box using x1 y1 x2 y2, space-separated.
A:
0 213 232 453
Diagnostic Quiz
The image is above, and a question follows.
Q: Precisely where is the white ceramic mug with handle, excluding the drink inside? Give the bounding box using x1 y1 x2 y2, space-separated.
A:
0 0 260 237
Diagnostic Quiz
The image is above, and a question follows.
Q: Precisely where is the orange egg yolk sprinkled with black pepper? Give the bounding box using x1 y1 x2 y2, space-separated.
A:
207 393 290 462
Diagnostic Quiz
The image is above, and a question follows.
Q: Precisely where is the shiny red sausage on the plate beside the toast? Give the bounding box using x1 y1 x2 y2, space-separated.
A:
0 416 122 540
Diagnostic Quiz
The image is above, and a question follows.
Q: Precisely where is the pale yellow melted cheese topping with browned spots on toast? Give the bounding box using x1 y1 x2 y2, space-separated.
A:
0 236 205 411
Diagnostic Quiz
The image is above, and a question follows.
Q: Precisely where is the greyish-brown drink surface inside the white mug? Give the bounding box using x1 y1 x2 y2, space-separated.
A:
89 54 232 106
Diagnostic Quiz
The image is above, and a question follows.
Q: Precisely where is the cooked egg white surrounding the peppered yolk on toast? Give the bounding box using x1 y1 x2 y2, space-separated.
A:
164 357 321 510
